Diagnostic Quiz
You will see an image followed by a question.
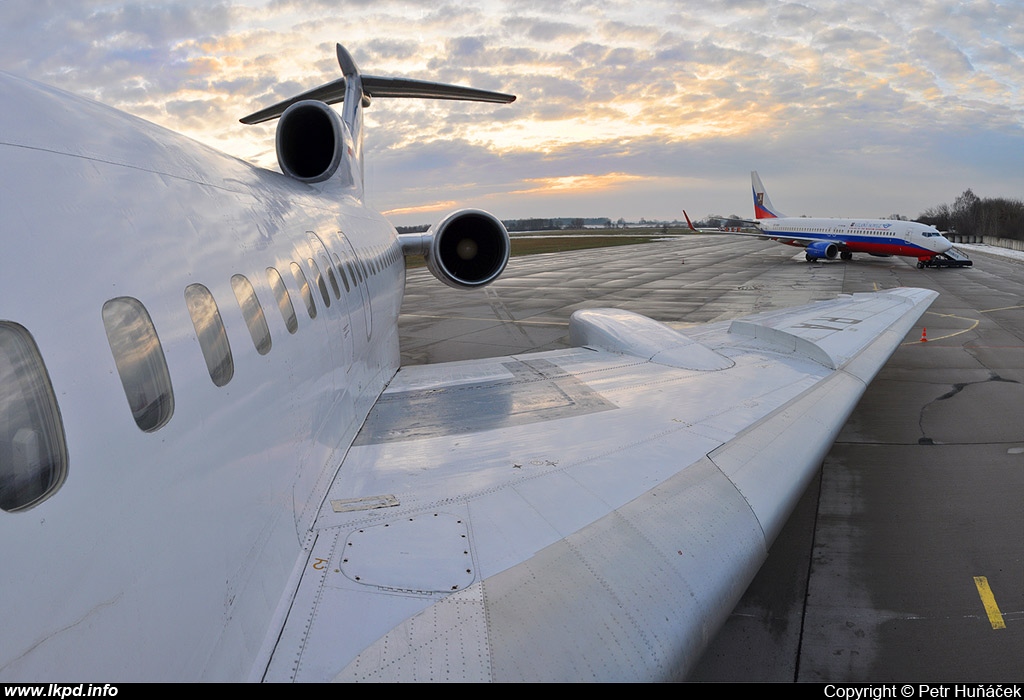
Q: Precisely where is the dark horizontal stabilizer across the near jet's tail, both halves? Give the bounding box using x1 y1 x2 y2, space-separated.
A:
240 76 515 124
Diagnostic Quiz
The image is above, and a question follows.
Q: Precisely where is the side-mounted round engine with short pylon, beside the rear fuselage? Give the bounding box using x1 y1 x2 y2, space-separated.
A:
398 209 511 289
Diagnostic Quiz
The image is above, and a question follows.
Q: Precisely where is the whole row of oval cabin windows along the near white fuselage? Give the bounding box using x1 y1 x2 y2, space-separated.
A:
0 237 401 513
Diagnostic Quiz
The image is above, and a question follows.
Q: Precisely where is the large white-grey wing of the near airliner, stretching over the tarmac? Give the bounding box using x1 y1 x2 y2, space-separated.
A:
263 289 937 682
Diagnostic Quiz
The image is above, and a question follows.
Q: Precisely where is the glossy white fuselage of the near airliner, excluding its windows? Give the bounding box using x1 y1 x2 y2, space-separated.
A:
0 71 404 680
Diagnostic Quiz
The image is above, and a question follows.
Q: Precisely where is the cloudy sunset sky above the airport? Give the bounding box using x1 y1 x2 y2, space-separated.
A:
0 0 1024 225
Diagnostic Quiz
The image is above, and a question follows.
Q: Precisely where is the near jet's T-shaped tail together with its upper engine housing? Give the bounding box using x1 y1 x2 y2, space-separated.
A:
241 44 515 200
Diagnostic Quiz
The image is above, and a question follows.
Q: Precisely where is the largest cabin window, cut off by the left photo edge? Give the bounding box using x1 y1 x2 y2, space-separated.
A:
0 322 68 513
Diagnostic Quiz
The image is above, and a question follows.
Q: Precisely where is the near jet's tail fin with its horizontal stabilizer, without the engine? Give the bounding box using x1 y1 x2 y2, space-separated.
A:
240 44 515 192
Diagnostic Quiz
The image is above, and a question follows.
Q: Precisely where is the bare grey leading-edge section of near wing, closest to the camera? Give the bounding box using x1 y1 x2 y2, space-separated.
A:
336 460 766 682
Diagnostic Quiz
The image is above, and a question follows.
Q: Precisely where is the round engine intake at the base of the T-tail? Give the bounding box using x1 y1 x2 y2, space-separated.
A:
276 99 350 182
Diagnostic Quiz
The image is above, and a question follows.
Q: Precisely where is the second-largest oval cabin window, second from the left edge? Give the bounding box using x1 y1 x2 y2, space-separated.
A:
102 297 174 433
